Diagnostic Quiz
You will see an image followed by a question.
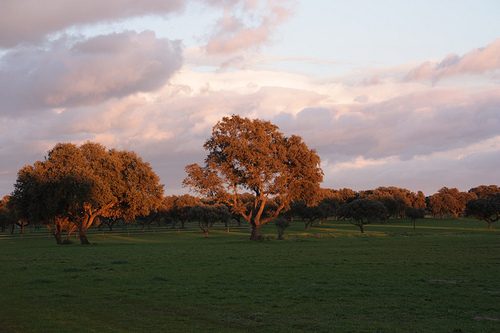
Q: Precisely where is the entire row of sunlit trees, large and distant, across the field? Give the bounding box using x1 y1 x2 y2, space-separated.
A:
0 115 500 244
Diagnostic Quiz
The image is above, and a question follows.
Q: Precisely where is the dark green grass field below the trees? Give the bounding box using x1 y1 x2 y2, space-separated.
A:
0 219 500 332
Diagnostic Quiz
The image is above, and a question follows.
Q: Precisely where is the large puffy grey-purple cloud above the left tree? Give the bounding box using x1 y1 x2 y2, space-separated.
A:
0 31 182 115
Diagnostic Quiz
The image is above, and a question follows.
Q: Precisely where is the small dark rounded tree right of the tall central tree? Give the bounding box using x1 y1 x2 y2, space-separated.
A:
338 199 388 233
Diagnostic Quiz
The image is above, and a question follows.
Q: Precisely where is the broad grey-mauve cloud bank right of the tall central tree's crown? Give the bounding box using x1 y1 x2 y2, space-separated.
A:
275 88 500 163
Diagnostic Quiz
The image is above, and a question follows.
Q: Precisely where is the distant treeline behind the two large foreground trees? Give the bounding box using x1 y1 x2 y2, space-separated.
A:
0 185 500 243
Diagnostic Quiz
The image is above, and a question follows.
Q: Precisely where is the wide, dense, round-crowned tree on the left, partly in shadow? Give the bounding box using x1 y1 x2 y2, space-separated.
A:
12 142 163 244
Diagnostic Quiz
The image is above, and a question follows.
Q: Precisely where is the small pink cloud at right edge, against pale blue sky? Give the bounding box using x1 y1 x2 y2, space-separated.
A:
404 39 500 83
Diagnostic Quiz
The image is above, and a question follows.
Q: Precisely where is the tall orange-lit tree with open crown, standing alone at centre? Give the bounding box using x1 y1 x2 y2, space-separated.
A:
183 115 323 240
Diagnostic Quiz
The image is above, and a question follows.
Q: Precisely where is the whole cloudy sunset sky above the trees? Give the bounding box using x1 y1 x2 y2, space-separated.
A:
0 0 500 197
